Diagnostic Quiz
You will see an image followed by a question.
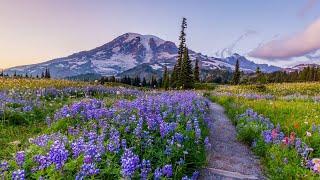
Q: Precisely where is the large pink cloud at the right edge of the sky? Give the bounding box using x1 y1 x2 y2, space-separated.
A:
249 18 320 59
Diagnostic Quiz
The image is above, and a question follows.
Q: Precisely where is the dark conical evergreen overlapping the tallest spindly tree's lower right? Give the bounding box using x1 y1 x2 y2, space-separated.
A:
180 47 194 89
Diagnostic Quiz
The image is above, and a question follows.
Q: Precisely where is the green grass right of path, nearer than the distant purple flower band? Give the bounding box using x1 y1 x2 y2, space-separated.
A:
210 96 320 179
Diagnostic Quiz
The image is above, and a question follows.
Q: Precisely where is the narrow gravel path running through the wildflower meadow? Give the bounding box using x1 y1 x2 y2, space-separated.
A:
200 103 265 179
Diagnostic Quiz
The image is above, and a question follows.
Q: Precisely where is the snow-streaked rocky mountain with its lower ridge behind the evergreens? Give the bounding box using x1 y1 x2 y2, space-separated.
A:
5 33 280 78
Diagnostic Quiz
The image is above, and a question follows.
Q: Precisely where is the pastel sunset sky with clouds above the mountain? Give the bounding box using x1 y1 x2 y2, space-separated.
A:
0 0 320 68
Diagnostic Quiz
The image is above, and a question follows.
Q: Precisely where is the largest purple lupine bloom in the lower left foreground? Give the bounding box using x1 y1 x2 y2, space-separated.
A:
49 141 69 169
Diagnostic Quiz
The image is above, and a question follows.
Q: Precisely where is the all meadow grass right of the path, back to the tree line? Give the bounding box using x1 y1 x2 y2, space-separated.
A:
210 83 320 179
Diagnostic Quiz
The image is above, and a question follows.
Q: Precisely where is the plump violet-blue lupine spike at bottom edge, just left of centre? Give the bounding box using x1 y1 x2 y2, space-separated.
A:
121 149 140 177
